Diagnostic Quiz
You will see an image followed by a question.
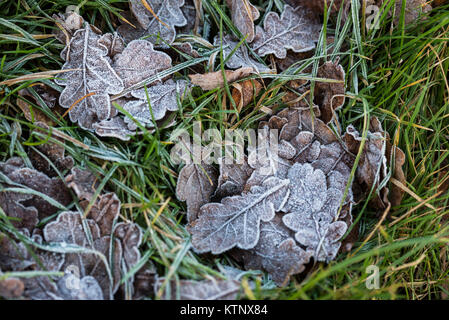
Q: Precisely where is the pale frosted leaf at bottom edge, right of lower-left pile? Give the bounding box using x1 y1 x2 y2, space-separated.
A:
155 278 241 300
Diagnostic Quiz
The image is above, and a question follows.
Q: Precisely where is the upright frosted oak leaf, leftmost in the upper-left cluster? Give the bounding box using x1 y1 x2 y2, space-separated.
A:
55 25 124 129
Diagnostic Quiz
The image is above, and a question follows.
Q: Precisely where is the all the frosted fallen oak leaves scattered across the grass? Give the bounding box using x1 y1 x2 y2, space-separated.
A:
0 0 416 299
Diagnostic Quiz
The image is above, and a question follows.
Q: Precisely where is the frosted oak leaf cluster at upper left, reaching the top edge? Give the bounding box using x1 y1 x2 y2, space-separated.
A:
36 0 321 140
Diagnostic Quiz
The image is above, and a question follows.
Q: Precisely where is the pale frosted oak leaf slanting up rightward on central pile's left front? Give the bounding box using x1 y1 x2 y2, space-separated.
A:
189 177 289 254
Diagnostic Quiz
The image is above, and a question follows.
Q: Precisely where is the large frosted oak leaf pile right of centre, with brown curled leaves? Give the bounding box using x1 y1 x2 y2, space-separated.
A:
177 58 405 285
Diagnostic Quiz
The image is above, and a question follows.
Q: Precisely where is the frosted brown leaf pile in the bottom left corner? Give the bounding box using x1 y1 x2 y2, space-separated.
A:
0 158 154 300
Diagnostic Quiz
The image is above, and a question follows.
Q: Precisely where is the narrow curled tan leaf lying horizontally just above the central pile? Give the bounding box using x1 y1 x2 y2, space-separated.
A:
189 67 254 90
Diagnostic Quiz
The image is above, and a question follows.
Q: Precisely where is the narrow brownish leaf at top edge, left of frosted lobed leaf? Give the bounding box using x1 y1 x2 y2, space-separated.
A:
226 0 260 43
